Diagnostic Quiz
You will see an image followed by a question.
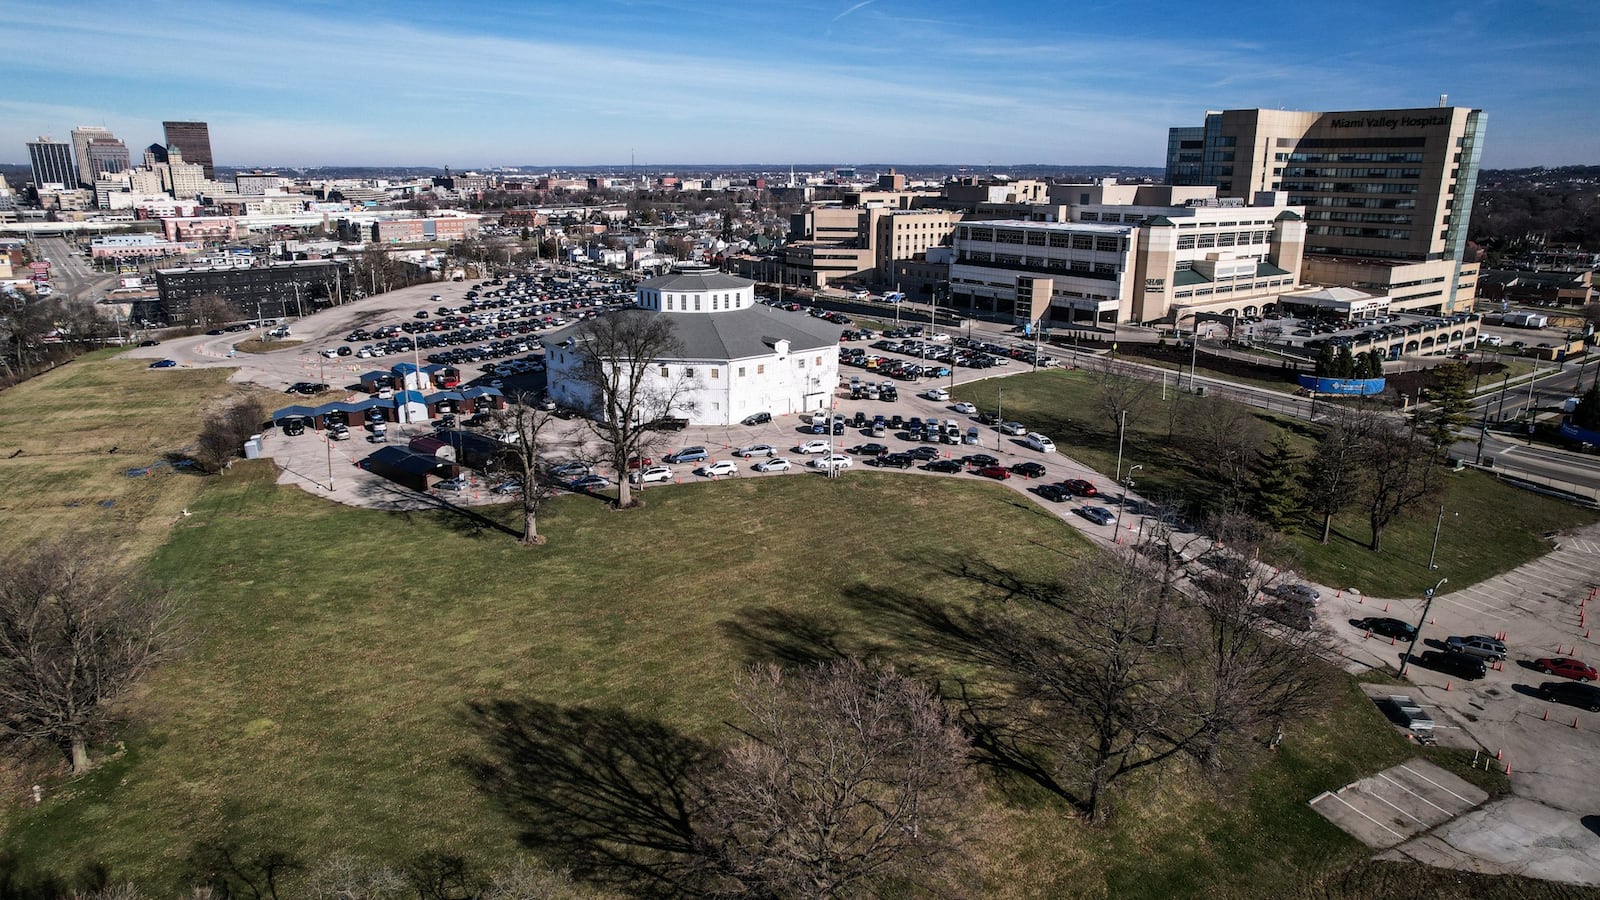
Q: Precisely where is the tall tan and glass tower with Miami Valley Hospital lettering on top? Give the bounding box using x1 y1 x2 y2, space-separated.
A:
1166 106 1486 312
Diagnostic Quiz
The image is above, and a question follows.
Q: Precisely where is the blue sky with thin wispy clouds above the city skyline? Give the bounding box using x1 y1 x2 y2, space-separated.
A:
0 0 1600 170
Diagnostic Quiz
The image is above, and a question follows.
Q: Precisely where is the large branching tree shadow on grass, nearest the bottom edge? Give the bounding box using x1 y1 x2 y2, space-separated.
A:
464 700 715 897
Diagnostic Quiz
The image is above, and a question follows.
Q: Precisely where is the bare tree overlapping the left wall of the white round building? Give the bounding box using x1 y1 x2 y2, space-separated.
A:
568 309 698 509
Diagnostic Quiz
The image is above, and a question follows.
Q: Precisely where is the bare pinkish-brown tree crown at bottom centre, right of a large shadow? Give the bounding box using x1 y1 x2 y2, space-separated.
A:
698 660 979 897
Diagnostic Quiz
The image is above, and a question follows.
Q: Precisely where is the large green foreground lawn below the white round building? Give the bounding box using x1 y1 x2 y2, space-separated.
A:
0 464 1523 897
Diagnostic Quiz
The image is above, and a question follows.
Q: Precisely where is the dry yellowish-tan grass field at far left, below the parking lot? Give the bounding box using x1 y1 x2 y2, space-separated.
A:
0 349 268 559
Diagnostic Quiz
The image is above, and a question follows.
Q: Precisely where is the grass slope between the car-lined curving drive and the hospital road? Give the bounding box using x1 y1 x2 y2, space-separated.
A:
955 370 1600 597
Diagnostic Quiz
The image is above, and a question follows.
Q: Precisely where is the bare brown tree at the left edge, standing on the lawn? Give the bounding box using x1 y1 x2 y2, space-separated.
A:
0 541 173 773
